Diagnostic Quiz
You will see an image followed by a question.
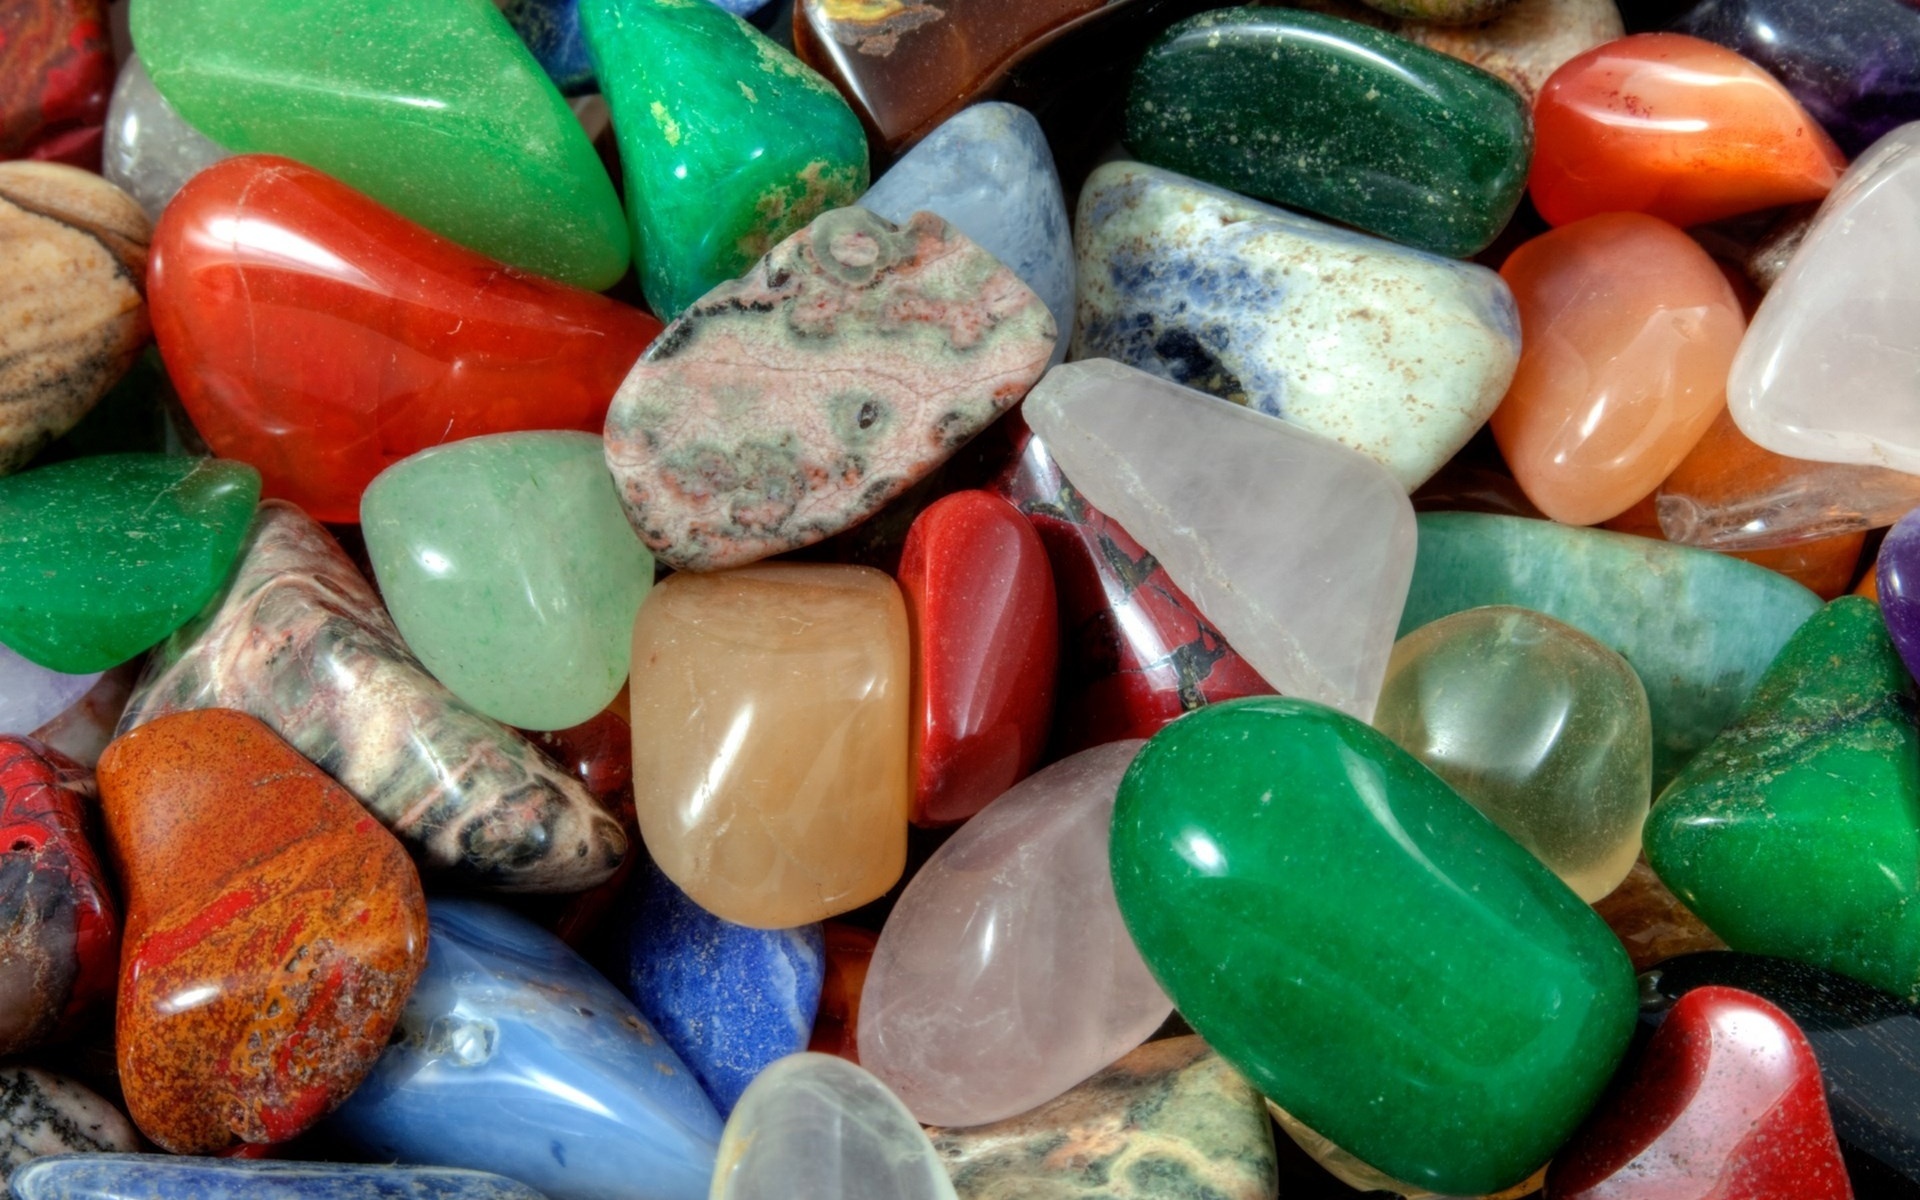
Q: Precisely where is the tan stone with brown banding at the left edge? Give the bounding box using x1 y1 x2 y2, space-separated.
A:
0 164 152 474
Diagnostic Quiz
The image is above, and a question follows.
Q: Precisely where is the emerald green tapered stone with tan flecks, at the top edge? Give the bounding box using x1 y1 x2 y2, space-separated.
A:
580 0 868 319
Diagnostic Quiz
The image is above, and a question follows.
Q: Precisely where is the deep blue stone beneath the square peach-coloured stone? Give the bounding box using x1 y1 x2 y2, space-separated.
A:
626 864 826 1114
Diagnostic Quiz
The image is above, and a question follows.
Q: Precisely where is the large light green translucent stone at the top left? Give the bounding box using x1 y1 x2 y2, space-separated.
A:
132 0 628 290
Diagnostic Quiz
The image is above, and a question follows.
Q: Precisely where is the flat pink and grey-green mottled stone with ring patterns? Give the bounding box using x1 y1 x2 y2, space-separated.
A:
607 208 1056 570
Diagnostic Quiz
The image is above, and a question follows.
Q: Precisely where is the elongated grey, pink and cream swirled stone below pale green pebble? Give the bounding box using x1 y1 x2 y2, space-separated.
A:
121 501 626 891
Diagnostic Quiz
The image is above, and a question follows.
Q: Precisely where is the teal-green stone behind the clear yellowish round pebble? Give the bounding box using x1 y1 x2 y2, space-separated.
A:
1400 513 1820 791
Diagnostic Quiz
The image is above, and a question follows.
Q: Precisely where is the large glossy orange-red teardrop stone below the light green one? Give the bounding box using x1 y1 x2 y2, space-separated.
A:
148 156 660 524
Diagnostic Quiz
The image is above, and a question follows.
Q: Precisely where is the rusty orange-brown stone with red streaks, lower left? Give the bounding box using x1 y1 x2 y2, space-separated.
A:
100 708 426 1154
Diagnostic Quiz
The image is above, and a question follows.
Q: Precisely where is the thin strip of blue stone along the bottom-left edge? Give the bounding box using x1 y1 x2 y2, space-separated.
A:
8 1154 541 1200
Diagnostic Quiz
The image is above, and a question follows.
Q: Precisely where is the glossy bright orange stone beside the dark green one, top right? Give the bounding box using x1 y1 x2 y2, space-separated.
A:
1526 33 1847 227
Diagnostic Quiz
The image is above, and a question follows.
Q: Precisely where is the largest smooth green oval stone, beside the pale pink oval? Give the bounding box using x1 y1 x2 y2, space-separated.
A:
1112 697 1636 1196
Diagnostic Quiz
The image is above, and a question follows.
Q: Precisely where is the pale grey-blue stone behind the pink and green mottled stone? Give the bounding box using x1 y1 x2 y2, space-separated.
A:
860 102 1073 363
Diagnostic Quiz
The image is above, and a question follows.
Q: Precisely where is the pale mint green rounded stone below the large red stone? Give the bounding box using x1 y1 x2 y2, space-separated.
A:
361 432 653 730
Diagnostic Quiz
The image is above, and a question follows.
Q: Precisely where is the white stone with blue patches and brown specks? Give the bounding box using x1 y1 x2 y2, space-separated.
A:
1073 163 1521 492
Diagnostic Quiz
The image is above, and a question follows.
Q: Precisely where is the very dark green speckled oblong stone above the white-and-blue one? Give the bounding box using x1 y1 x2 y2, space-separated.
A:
1127 8 1534 255
